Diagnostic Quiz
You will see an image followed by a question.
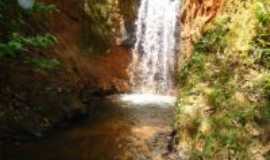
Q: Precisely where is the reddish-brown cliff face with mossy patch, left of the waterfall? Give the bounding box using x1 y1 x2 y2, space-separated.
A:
41 0 136 92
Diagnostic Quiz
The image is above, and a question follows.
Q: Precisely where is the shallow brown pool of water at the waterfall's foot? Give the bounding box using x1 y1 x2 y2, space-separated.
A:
3 95 177 160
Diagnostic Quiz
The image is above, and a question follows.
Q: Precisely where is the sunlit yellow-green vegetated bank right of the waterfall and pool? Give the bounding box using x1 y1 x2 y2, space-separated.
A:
176 0 270 160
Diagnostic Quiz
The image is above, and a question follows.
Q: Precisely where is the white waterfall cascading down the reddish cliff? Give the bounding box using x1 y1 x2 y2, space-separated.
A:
130 0 180 95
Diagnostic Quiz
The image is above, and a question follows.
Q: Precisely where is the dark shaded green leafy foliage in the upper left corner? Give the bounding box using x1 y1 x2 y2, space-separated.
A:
0 0 59 69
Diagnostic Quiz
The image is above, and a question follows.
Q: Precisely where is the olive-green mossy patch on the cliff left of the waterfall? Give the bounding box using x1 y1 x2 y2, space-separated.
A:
82 0 118 53
